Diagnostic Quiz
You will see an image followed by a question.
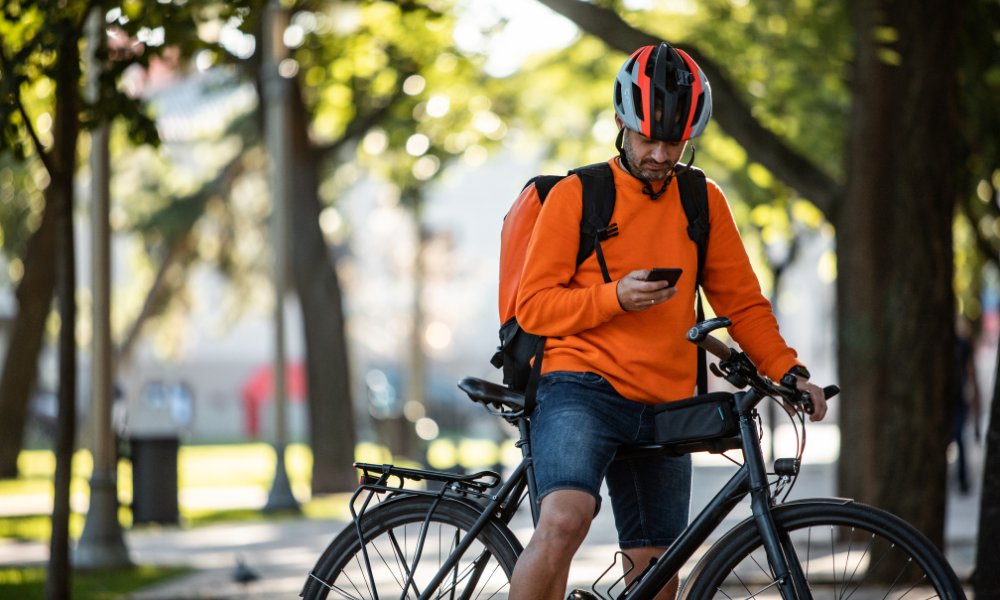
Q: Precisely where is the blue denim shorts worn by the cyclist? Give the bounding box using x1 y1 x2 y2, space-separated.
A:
531 371 691 550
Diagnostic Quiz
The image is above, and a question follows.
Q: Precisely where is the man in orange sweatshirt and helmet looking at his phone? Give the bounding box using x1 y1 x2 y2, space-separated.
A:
510 44 826 600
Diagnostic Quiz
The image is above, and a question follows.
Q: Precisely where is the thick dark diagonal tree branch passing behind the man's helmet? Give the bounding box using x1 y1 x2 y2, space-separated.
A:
538 0 844 221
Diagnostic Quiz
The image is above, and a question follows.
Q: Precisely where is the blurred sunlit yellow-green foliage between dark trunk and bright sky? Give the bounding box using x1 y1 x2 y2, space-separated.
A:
292 2 515 210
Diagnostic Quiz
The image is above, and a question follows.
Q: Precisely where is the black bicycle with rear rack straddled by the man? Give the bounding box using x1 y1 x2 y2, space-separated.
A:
300 317 965 600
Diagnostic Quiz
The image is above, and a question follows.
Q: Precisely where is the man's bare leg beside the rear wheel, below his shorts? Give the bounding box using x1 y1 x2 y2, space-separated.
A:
510 490 596 600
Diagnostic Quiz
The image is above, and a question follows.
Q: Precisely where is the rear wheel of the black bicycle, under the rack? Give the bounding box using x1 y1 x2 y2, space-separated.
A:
302 496 522 600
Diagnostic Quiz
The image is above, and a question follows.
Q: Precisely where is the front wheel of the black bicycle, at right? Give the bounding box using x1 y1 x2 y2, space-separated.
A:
680 501 965 600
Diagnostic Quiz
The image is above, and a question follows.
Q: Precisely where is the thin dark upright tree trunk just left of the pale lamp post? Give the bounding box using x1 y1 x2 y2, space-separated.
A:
45 33 80 600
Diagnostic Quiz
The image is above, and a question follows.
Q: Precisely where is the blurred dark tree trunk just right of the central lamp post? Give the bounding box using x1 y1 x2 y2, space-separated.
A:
289 86 358 494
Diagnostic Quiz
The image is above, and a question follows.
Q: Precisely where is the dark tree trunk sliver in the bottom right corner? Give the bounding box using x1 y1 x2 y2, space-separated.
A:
972 352 1000 600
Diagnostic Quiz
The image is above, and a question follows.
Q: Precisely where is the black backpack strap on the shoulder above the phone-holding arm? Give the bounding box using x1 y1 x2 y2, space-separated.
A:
570 162 618 283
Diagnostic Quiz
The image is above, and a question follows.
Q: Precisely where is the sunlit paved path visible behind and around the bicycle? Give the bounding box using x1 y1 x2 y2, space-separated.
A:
0 464 979 600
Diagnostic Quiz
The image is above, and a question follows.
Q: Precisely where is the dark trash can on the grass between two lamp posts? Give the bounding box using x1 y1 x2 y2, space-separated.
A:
129 437 180 524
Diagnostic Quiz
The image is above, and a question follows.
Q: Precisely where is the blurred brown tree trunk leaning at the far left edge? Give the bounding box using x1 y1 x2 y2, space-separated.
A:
0 172 61 479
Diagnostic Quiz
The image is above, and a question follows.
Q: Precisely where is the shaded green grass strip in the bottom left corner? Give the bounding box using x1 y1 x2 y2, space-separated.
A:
0 566 191 600
